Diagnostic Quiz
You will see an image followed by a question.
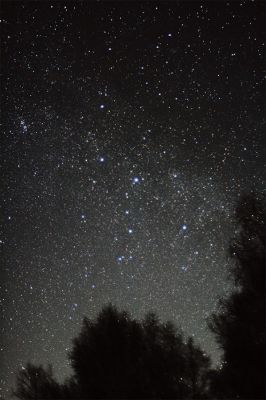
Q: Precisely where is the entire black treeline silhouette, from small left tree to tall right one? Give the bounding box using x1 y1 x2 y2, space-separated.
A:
13 196 266 400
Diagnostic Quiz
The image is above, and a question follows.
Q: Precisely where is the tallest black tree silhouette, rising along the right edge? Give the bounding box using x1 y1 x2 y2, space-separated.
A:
209 195 266 399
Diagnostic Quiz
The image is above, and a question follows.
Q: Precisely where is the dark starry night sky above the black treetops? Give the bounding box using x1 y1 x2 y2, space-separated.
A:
0 1 265 394
